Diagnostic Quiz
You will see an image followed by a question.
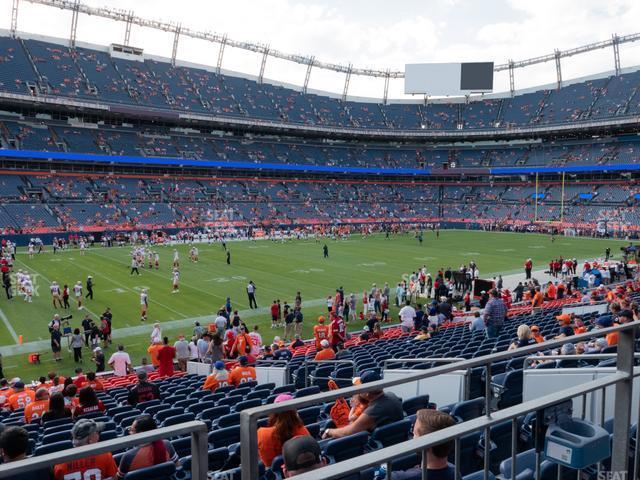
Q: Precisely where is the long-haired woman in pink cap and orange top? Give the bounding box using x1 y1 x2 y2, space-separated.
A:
258 393 309 467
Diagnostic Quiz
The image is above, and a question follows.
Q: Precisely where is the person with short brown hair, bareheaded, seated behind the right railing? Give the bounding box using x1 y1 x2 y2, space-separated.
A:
382 409 456 480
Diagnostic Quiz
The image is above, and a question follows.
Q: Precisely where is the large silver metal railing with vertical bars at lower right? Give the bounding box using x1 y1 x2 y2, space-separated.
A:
240 321 640 480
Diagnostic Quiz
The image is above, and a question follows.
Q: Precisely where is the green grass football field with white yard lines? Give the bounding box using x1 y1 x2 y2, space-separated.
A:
0 231 622 379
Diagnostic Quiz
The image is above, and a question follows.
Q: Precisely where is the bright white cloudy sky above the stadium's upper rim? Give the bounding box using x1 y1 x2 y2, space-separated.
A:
0 0 640 99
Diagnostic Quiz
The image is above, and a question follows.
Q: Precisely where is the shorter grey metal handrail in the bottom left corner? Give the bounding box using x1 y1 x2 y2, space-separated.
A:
0 421 209 480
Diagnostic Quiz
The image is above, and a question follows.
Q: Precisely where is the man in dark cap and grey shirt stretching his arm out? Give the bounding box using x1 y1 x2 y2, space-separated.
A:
323 370 404 438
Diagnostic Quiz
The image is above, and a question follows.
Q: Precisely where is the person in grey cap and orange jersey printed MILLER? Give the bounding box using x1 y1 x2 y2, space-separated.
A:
53 418 118 480
